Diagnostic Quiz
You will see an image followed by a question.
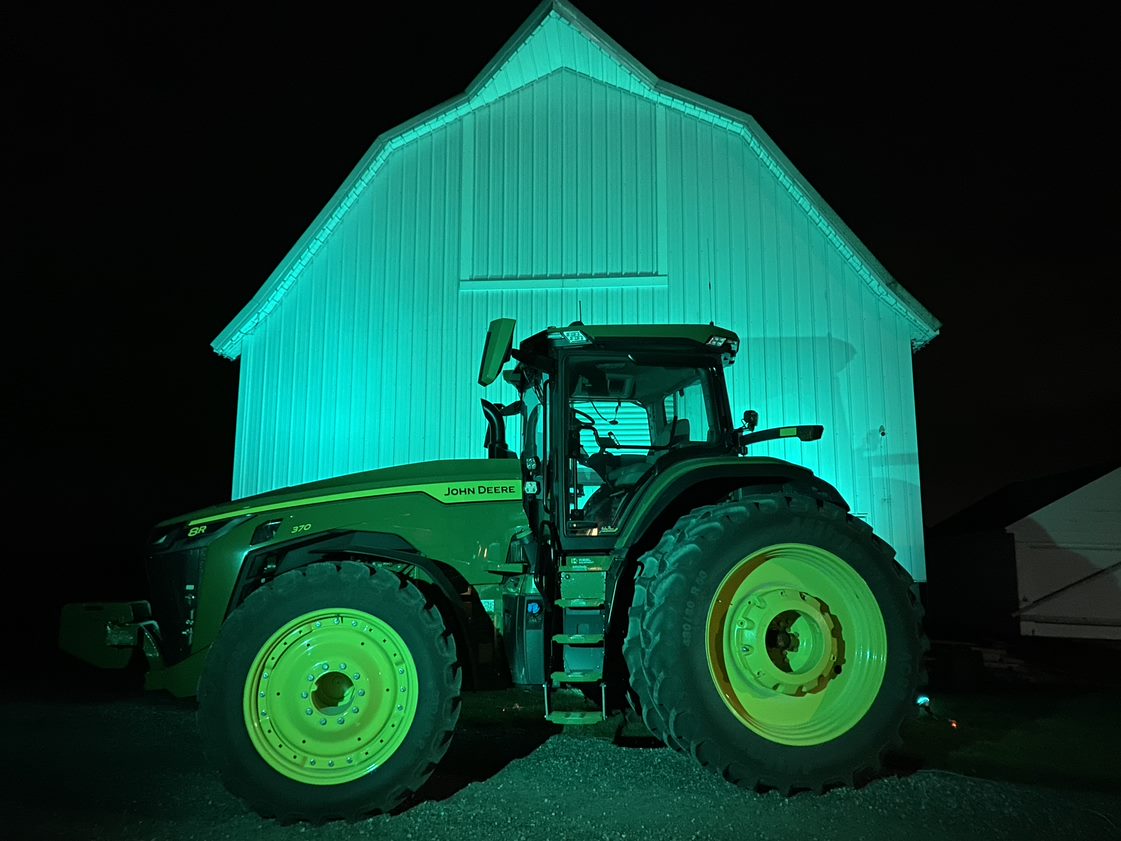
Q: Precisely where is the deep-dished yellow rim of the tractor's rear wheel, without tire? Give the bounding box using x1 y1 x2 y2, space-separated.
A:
705 544 888 746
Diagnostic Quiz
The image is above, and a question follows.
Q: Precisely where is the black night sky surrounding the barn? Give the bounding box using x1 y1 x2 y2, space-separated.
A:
0 0 1121 598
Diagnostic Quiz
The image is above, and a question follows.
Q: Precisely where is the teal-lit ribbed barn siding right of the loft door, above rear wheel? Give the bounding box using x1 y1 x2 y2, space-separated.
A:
664 111 925 576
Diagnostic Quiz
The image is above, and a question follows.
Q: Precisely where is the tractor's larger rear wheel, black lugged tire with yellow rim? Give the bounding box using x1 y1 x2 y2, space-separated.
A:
623 495 926 793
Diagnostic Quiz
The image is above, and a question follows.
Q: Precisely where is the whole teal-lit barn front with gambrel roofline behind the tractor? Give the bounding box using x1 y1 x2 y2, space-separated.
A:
215 3 937 580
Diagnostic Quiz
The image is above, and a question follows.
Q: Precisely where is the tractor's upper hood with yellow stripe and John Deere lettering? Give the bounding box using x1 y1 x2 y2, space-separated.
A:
159 459 521 527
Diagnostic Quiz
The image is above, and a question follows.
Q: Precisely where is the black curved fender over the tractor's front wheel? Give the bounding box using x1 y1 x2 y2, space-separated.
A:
228 530 478 681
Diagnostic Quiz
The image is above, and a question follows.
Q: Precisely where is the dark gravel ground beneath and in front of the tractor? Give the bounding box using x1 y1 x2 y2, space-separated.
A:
0 690 1121 841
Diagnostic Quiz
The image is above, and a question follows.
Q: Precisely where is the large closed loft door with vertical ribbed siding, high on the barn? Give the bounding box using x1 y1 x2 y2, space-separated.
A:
461 71 658 279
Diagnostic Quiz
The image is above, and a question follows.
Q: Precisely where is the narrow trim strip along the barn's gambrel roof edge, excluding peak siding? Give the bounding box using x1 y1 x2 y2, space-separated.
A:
211 0 942 359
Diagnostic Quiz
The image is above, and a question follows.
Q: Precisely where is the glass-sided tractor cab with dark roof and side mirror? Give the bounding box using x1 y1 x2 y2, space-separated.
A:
479 318 740 551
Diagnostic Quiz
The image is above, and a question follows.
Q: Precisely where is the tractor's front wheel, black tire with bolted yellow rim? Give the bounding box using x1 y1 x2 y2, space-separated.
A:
198 563 461 821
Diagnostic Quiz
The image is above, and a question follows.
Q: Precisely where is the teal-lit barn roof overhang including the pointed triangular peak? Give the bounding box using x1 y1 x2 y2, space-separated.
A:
211 0 942 359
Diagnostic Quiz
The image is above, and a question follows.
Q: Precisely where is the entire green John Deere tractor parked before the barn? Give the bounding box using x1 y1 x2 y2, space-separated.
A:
61 318 925 821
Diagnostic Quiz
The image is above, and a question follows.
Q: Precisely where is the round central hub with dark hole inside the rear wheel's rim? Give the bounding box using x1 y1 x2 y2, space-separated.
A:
731 588 837 695
